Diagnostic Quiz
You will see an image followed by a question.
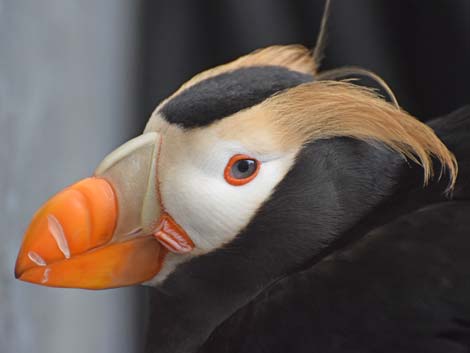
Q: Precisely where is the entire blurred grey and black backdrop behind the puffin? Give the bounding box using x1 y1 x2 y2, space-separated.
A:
0 0 470 353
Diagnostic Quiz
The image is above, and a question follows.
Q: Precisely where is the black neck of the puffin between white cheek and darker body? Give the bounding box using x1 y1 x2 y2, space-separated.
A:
148 138 438 353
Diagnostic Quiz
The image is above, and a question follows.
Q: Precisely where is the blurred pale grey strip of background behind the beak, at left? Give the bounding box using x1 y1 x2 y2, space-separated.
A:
0 0 146 353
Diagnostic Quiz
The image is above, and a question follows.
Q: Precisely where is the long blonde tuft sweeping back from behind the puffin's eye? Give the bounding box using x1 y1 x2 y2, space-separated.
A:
256 81 457 188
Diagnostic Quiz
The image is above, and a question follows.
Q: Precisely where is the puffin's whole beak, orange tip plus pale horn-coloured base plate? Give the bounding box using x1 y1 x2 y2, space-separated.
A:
15 133 178 289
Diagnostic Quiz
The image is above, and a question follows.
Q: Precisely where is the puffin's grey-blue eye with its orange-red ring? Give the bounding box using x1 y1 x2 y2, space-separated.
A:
224 154 260 186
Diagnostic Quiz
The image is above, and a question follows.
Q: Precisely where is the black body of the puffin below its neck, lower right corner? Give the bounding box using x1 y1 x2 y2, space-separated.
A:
201 202 470 353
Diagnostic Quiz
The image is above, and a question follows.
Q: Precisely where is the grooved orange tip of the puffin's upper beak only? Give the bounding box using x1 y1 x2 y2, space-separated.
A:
15 178 117 277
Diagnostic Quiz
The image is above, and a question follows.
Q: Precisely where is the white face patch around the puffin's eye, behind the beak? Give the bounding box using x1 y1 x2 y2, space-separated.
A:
143 130 297 284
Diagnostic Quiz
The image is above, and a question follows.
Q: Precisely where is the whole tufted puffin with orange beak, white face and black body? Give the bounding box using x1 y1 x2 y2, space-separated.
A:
15 9 470 353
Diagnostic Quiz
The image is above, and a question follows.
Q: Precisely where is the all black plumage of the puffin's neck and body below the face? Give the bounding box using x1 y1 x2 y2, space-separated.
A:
148 108 470 353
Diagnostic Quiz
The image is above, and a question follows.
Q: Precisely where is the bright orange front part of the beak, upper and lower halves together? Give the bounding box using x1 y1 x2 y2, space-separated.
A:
15 177 166 289
